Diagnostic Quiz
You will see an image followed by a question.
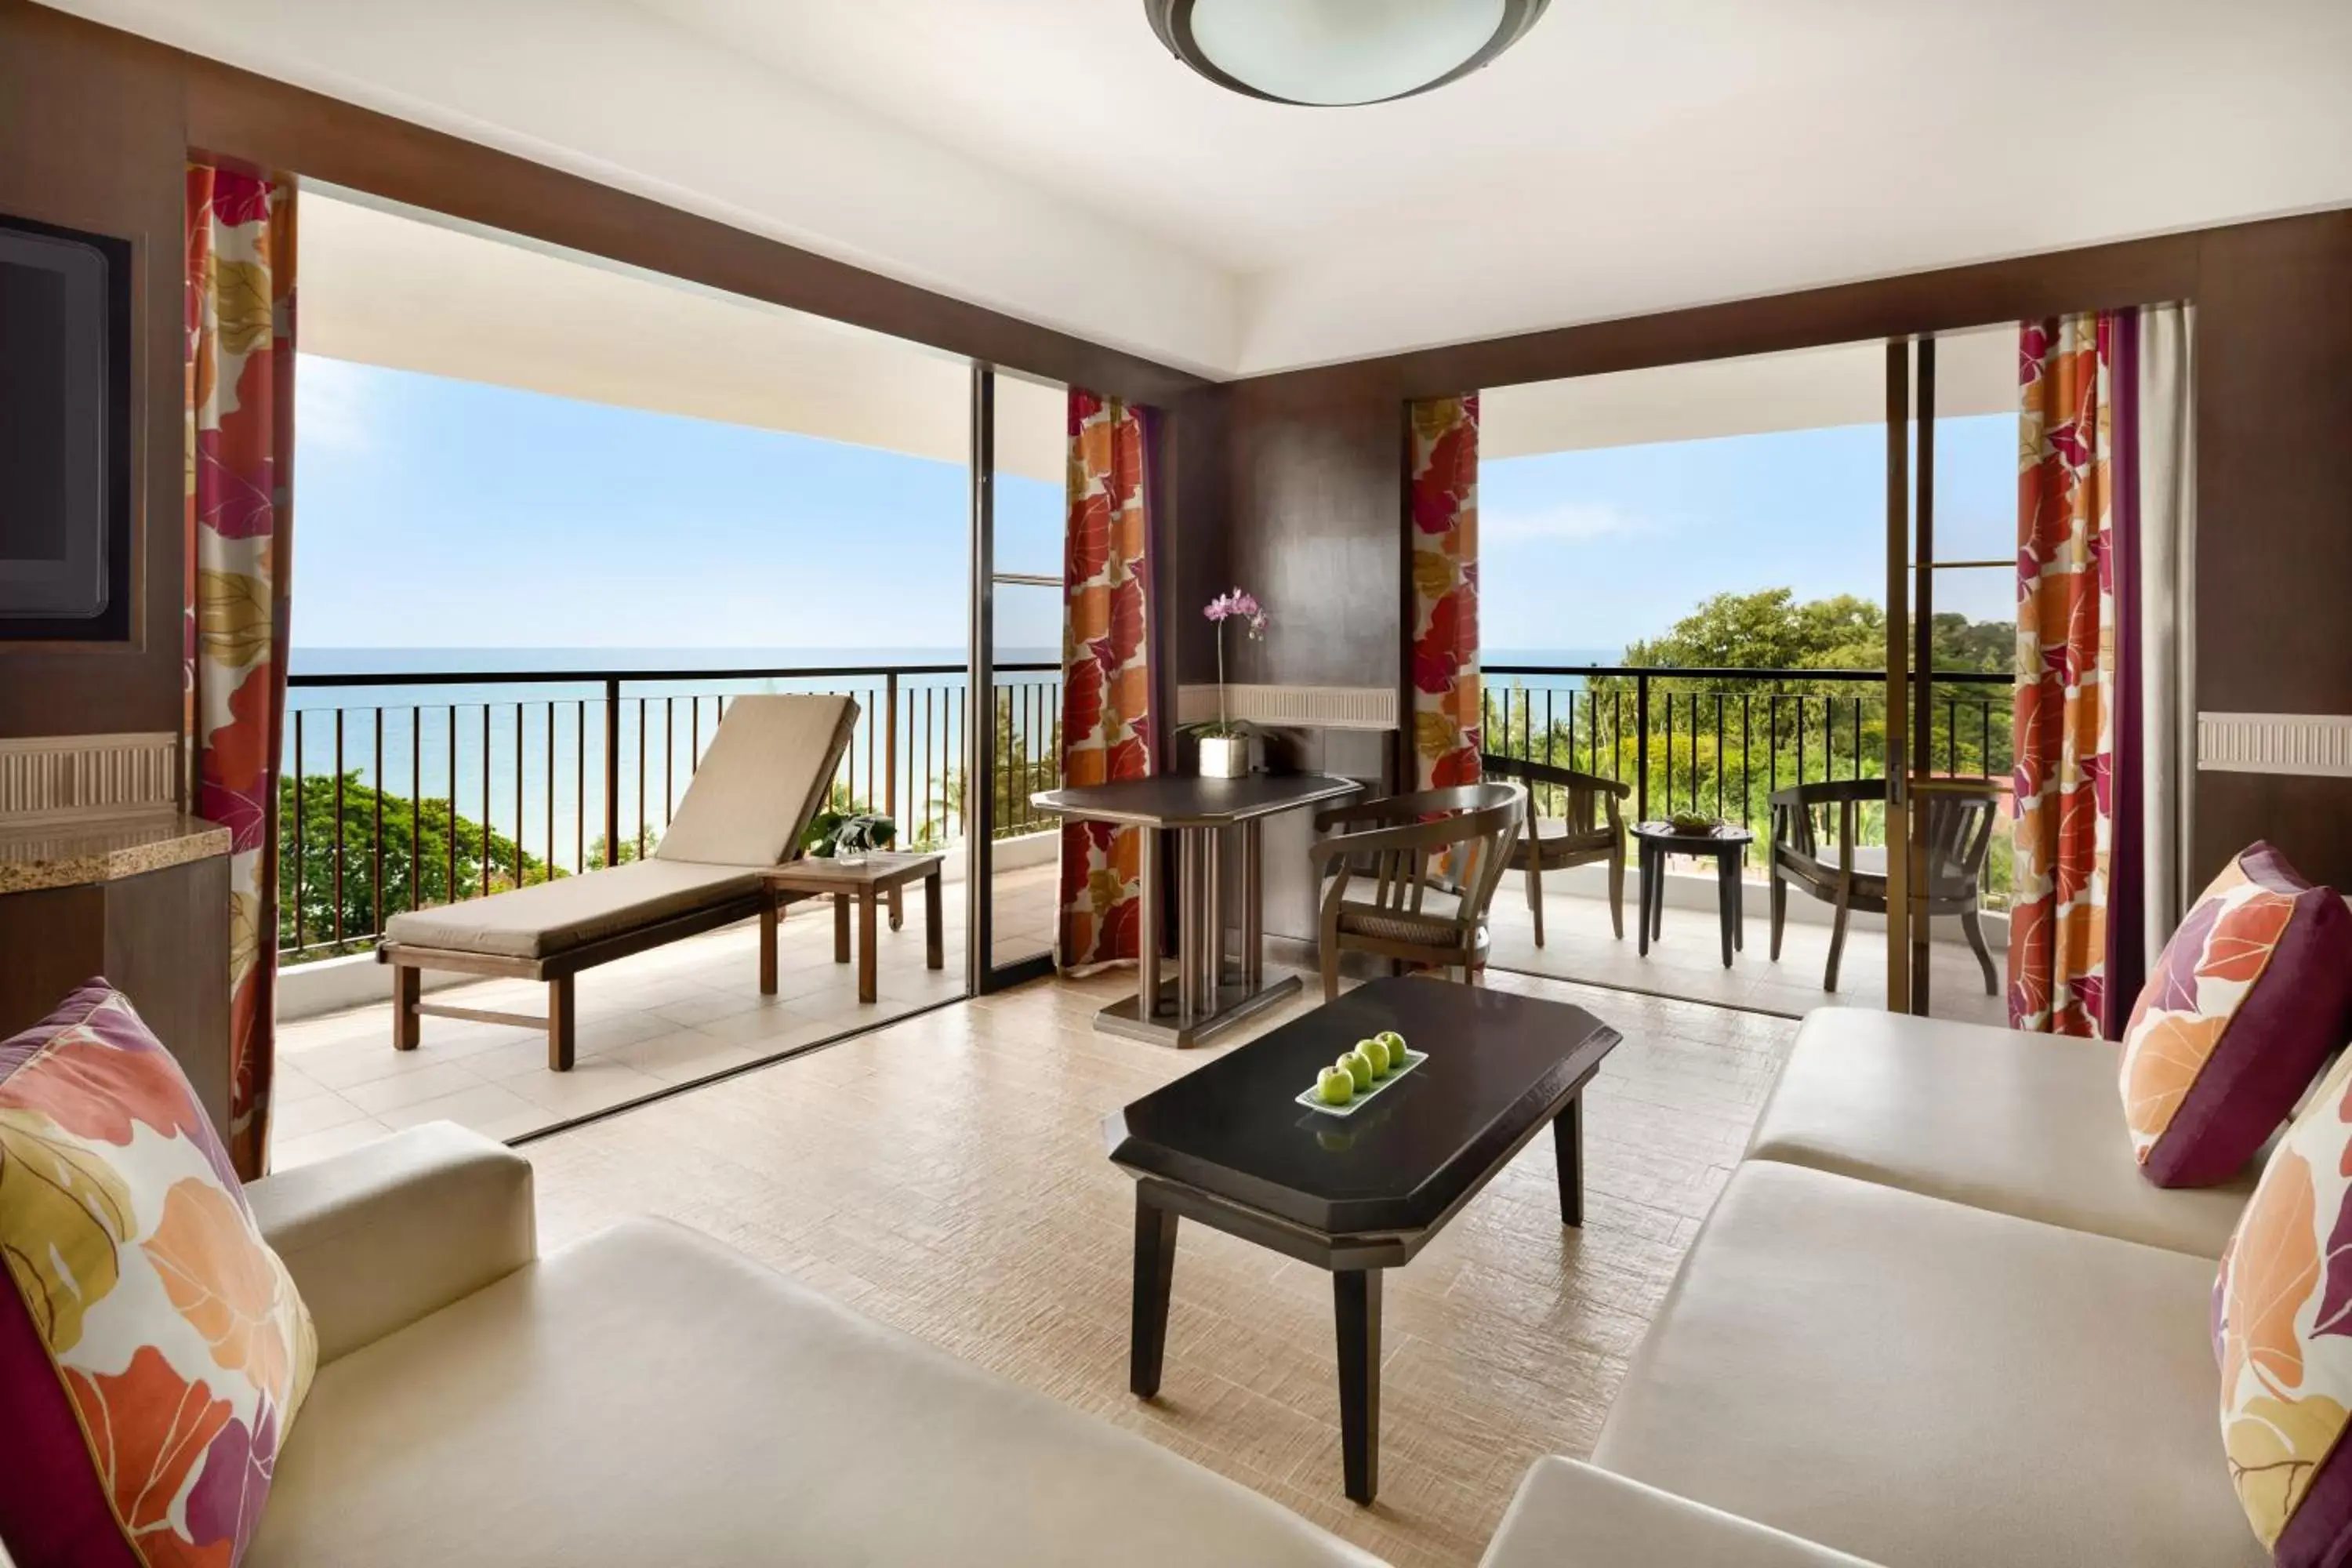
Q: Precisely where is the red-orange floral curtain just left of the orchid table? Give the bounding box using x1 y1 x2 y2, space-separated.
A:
1061 386 1157 968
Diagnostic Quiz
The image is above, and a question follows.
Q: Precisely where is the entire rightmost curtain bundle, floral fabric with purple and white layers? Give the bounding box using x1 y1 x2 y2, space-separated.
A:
2009 306 2197 1039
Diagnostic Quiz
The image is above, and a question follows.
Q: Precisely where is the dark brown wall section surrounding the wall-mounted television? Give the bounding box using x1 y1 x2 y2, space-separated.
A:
0 2 186 736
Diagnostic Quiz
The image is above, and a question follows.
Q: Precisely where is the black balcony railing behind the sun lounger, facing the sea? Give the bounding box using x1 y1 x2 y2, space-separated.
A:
275 663 1061 961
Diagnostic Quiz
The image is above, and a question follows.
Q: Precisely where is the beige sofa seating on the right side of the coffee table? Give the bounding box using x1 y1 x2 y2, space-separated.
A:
1486 1008 2270 1568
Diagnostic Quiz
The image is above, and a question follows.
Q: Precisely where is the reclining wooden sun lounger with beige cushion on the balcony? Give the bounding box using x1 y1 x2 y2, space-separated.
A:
376 696 858 1072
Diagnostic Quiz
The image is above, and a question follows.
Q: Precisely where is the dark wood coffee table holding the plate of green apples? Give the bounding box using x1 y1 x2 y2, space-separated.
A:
1103 978 1621 1502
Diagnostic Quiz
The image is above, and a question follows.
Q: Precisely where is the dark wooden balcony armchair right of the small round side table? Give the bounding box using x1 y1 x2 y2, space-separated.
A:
1771 779 2002 996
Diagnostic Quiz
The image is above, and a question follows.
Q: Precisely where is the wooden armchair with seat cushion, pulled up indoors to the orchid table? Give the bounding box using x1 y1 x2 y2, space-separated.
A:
1312 783 1526 1001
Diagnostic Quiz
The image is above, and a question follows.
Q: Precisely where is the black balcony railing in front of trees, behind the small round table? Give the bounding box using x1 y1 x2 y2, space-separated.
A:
1482 666 2013 907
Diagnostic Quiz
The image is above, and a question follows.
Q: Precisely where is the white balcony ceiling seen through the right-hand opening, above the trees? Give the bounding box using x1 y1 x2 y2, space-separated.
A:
1477 327 2018 459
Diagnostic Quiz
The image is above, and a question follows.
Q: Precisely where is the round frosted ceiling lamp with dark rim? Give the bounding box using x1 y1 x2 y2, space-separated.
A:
1143 0 1550 106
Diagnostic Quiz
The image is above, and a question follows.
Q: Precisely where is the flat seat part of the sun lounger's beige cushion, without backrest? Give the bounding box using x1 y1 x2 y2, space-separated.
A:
383 858 760 959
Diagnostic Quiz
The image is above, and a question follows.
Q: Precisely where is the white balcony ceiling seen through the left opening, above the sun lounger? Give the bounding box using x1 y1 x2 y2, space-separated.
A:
301 191 1068 485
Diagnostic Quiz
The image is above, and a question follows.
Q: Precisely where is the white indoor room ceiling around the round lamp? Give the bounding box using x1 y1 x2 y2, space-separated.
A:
50 0 2352 376
